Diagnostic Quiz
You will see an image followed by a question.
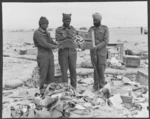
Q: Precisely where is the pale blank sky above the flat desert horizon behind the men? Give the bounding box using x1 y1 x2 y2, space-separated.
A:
2 1 148 29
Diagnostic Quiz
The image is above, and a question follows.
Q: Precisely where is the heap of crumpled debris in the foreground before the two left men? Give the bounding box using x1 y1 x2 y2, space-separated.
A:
2 83 118 118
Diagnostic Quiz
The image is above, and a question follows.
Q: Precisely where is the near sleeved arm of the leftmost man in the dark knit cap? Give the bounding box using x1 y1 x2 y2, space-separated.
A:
34 32 55 49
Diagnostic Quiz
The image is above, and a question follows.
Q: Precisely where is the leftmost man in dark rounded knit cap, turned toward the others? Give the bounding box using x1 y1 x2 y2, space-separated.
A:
33 17 57 93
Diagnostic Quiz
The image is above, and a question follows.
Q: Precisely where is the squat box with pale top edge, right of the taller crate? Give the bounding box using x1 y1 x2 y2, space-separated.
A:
124 55 140 67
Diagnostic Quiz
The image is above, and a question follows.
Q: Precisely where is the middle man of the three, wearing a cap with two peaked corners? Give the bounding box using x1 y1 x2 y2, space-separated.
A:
56 13 77 88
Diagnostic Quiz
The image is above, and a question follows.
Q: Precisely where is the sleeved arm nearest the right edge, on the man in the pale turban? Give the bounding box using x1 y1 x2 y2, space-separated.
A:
96 26 109 49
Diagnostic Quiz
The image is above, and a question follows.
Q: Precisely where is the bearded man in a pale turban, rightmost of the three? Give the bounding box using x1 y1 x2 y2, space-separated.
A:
89 13 109 91
